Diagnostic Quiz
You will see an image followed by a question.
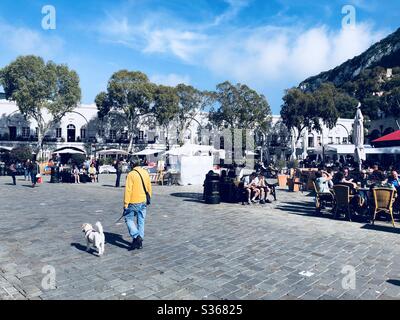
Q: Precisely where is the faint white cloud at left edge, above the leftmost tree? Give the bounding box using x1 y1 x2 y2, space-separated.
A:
0 22 64 59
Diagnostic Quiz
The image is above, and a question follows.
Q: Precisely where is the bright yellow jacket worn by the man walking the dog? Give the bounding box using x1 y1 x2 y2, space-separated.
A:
124 167 152 208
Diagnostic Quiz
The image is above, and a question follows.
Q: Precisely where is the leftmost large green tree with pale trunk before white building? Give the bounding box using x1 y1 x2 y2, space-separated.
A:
0 56 81 157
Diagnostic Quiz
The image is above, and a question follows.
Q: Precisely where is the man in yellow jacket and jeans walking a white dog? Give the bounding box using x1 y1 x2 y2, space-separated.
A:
124 162 152 250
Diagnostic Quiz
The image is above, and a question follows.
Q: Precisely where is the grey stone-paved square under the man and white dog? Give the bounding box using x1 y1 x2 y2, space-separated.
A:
0 172 400 299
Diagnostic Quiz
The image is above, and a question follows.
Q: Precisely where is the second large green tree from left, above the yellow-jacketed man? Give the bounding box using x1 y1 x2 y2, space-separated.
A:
95 70 155 152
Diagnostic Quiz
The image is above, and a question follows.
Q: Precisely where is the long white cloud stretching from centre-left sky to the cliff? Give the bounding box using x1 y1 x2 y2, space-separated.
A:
96 5 386 87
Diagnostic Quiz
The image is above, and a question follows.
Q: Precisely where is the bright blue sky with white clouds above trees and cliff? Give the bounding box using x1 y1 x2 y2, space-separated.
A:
0 0 400 114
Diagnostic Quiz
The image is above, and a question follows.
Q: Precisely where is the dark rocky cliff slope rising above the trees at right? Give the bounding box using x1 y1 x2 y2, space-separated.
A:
299 28 400 91
